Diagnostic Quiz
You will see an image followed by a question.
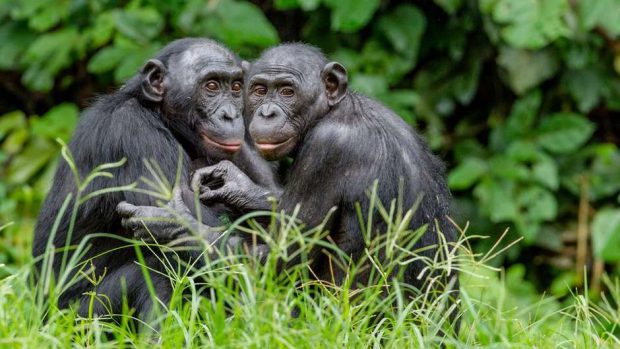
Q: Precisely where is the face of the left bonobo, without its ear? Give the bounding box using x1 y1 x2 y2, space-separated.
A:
142 42 245 159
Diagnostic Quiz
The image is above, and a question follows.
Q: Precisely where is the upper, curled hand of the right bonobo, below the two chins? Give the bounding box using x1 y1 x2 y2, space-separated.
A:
192 160 276 211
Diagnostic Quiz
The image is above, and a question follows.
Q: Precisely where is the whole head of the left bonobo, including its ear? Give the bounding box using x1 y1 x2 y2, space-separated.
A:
141 39 245 159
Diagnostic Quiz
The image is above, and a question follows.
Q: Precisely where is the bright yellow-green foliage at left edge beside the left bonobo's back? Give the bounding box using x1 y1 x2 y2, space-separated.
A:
0 103 78 266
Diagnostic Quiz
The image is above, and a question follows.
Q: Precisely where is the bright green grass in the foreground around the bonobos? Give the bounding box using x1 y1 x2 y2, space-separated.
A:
0 143 620 348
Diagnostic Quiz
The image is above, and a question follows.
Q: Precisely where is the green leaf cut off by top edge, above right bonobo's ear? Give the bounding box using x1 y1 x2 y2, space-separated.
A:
323 0 380 33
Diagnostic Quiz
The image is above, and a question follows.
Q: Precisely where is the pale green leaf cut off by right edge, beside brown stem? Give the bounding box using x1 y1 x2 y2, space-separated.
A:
591 208 620 262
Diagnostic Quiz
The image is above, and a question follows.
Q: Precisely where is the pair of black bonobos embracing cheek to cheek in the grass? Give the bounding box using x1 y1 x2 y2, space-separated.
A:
33 39 458 326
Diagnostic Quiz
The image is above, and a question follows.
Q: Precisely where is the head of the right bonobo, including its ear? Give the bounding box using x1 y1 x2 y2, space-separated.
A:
246 44 347 160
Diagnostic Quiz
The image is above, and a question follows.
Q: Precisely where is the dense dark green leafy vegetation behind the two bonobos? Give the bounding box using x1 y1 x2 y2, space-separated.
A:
0 0 620 345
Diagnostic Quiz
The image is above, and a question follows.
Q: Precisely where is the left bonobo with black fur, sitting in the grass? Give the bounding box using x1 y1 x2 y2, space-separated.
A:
33 39 274 316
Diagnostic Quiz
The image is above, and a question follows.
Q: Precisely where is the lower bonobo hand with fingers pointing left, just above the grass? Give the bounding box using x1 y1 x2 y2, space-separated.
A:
116 188 209 242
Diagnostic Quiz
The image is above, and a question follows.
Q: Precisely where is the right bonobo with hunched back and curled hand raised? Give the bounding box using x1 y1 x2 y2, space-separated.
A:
191 44 458 304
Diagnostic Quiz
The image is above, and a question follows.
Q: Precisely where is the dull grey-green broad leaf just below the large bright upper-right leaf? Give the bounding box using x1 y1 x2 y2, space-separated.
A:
497 46 559 95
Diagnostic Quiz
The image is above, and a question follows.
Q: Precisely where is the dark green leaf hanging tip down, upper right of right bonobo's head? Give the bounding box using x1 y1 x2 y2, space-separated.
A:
378 5 426 62
